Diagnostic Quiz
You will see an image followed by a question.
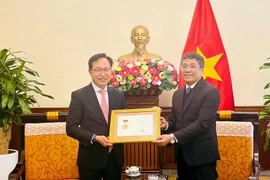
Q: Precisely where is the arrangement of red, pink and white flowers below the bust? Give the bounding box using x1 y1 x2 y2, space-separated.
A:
109 59 178 92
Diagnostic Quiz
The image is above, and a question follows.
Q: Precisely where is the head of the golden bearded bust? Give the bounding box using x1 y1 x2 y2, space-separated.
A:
130 25 150 51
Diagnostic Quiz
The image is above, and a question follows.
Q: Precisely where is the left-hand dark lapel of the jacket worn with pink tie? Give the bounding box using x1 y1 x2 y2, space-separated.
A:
87 83 107 124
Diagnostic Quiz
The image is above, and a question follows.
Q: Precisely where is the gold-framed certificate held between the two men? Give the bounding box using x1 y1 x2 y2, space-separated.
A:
109 107 160 143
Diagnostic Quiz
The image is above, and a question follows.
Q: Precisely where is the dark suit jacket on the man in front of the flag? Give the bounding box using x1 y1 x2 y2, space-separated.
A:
167 78 220 166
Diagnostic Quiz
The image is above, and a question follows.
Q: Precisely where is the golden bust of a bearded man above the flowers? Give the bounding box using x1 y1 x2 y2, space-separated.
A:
118 25 162 61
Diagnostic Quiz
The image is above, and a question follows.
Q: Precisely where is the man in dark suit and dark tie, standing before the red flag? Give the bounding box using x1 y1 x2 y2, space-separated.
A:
156 53 220 180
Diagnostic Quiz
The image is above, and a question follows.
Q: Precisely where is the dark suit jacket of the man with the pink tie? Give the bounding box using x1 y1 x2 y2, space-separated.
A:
66 83 125 170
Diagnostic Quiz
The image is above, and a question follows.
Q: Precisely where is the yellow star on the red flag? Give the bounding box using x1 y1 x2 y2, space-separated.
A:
196 47 223 81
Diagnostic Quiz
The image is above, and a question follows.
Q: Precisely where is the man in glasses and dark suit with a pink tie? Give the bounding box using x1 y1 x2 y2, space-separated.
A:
66 53 125 180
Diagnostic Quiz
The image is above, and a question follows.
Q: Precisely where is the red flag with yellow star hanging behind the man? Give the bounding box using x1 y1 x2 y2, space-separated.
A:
179 0 234 111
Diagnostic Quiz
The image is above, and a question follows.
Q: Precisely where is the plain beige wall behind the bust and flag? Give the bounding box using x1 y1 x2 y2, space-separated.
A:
0 0 270 107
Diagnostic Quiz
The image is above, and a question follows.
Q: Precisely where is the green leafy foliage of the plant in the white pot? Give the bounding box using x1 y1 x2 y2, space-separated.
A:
0 49 53 130
